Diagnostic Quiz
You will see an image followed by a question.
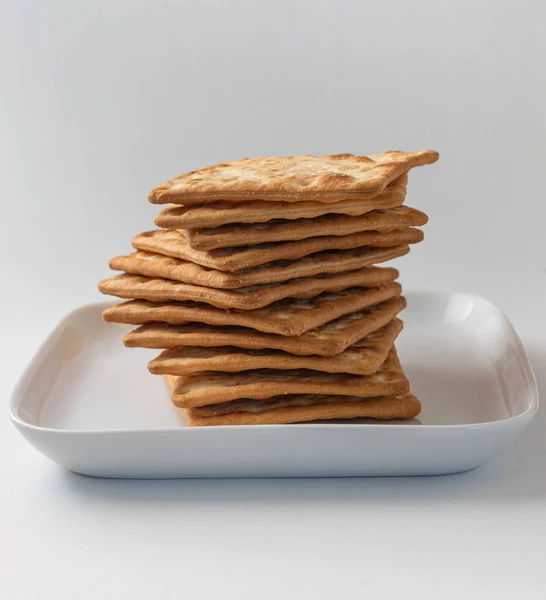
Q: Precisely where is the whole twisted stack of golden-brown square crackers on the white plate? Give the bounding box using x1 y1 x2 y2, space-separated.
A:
99 150 438 426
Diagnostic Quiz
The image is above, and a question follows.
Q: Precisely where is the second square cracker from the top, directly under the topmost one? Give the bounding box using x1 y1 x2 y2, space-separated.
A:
154 174 408 229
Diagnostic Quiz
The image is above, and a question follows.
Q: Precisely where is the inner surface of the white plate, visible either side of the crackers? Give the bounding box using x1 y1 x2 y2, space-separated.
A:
12 292 536 431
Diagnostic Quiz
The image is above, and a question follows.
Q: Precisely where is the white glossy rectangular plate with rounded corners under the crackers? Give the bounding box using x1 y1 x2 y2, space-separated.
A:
10 292 538 478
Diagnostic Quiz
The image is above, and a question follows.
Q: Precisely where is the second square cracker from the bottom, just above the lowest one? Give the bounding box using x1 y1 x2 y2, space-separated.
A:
168 348 409 408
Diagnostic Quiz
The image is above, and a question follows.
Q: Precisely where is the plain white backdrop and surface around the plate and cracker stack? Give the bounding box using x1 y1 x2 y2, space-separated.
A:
0 0 546 600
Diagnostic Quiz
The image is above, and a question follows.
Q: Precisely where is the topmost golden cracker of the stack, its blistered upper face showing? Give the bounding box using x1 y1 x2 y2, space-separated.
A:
148 150 439 205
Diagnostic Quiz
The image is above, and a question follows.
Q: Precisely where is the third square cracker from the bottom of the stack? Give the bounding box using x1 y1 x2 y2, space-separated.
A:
148 319 402 375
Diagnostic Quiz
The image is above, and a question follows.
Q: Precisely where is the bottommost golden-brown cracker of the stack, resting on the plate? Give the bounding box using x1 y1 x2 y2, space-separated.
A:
177 394 421 427
